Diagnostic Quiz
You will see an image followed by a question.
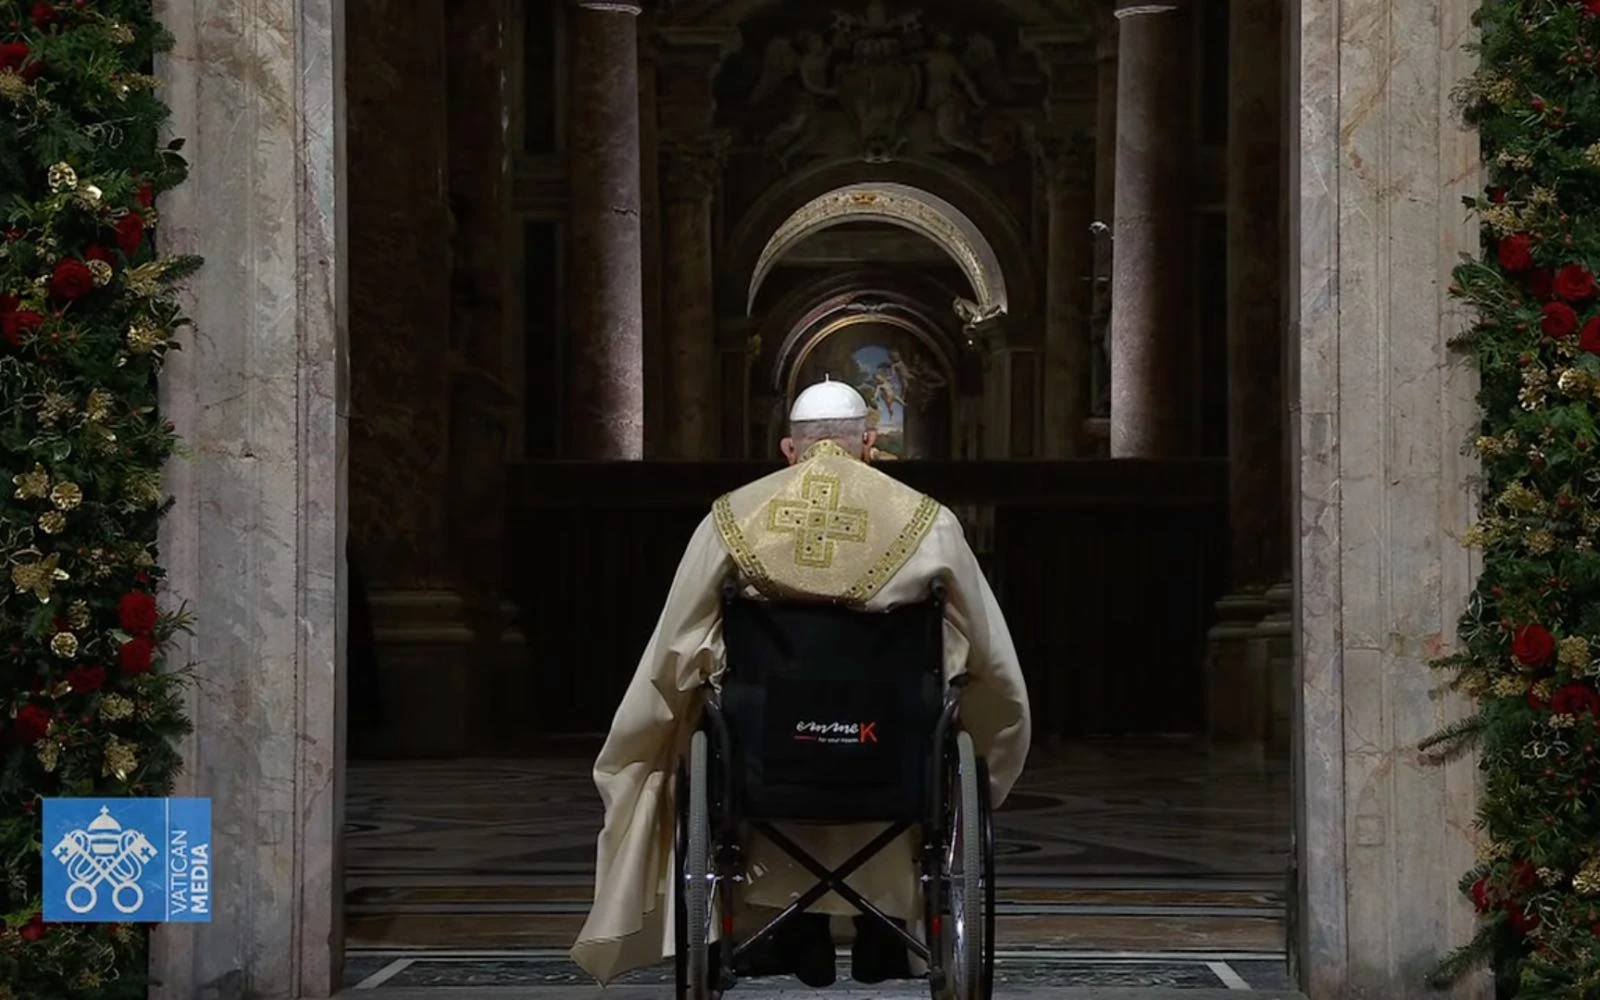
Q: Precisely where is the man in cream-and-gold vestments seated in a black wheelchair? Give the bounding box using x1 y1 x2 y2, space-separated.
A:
573 381 1029 1000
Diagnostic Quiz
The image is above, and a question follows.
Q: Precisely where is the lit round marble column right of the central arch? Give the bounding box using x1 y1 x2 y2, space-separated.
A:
1110 0 1194 458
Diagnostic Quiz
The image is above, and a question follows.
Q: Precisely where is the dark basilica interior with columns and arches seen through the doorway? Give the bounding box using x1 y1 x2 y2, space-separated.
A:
334 0 1293 995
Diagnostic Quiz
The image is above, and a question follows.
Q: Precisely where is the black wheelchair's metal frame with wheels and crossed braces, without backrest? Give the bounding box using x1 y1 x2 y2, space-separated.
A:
674 579 995 1000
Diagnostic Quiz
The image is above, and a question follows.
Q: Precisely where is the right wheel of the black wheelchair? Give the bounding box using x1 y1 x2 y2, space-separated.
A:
946 733 994 1000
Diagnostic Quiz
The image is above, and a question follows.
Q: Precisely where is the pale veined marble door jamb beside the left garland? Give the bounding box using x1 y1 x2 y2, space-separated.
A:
150 0 349 1000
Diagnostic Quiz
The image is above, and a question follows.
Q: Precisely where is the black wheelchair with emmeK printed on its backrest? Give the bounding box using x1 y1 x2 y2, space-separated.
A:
674 579 995 1000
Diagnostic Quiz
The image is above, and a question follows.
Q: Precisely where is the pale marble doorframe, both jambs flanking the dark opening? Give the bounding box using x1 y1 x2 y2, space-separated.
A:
154 0 1488 1000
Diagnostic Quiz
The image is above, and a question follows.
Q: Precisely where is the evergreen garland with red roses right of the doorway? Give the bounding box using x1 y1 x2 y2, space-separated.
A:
1426 0 1600 1000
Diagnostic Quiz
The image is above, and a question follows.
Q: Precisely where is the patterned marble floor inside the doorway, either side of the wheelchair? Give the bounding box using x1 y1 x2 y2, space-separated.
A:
346 742 1290 1000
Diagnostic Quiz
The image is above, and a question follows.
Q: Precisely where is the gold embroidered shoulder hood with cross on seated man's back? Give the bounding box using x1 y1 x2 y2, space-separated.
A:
712 442 939 603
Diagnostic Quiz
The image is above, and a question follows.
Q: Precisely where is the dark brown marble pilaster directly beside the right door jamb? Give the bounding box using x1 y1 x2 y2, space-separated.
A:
1227 0 1288 587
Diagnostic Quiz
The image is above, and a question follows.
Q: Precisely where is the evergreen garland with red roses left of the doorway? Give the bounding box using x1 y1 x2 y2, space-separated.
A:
0 0 198 1000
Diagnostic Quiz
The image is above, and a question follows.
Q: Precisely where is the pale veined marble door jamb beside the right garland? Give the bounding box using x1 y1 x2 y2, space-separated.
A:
1285 0 1493 1000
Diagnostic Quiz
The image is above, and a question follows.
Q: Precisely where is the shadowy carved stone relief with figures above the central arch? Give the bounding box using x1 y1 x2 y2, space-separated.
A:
736 0 1037 166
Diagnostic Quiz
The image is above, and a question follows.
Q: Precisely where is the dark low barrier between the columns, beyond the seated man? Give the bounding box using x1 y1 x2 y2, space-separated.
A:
506 461 1226 736
